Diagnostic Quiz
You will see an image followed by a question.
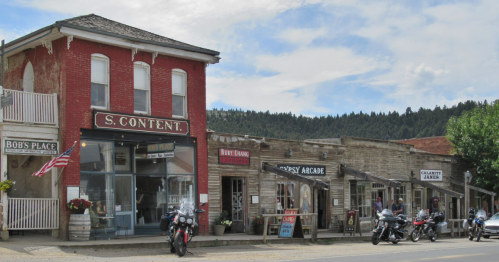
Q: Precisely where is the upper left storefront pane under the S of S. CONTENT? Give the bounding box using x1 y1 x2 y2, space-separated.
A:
80 140 113 172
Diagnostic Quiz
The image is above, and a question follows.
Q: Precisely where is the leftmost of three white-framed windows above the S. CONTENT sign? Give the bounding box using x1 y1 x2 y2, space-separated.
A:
91 54 109 109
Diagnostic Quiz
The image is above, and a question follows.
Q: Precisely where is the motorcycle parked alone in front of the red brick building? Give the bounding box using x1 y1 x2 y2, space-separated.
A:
160 203 206 257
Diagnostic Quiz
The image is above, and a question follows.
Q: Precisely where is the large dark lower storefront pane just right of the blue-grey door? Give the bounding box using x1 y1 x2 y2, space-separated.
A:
135 176 166 225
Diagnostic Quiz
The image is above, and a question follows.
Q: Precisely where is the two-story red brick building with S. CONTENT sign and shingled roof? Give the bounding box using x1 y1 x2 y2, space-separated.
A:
2 14 220 238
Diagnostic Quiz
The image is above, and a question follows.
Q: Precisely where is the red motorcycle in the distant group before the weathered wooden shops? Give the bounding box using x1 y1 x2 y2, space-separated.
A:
411 210 445 242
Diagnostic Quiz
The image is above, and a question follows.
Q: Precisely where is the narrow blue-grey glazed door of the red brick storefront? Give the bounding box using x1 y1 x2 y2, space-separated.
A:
115 175 134 235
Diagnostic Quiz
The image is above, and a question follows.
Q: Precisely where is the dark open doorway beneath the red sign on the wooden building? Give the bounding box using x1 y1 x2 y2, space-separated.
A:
222 176 246 233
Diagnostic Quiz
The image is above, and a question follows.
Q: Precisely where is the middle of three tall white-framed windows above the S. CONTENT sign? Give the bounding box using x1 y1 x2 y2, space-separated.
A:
133 62 151 114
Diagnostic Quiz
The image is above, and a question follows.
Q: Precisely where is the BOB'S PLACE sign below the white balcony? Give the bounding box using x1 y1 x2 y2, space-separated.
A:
3 139 59 155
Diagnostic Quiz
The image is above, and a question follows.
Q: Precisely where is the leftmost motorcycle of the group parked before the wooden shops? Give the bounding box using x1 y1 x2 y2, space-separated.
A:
371 209 404 245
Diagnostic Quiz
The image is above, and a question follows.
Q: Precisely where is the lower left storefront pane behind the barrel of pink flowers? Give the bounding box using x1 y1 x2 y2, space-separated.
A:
80 174 114 228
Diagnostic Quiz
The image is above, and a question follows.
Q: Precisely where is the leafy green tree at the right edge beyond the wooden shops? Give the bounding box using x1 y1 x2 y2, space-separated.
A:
447 100 499 191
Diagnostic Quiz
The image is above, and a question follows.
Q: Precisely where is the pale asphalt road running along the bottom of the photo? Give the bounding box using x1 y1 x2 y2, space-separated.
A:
0 238 499 262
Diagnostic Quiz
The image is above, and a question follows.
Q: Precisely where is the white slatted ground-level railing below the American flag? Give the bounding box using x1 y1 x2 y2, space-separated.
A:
8 198 59 230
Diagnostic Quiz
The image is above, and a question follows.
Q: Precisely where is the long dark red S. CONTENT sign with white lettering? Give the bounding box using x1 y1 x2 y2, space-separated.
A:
94 110 190 136
